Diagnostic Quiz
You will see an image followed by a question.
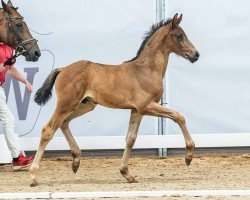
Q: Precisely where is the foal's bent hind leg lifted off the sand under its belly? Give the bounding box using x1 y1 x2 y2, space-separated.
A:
61 101 96 173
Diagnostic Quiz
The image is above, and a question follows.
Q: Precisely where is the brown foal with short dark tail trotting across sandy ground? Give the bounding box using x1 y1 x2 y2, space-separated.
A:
29 14 199 186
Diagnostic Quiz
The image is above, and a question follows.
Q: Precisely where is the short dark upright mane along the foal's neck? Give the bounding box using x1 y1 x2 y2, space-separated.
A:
125 18 172 62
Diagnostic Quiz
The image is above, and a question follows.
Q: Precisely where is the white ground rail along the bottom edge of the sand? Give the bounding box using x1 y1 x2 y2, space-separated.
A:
0 190 250 199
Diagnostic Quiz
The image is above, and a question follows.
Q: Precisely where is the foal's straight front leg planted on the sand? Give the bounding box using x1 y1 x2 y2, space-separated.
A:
120 110 143 183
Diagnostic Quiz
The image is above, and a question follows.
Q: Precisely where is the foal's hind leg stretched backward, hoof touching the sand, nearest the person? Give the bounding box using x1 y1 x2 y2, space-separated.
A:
29 105 77 186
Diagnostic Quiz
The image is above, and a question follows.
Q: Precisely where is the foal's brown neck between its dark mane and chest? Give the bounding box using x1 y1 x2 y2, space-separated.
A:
137 26 171 78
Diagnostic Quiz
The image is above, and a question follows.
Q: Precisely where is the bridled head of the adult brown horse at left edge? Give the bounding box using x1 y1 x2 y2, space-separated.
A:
0 0 41 62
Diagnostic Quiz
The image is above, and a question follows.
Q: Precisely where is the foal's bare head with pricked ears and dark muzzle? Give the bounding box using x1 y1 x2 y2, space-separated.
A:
170 14 200 63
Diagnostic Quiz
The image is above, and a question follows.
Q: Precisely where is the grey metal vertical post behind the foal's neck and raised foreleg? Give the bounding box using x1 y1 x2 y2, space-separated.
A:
156 0 167 157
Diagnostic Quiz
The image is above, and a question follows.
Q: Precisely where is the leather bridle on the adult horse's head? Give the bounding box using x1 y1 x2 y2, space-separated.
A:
4 12 38 58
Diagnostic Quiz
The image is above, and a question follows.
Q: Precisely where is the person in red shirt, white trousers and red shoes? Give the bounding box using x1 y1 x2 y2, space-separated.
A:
0 42 34 170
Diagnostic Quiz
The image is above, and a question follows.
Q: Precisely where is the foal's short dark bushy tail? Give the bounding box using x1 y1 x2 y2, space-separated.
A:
34 68 61 106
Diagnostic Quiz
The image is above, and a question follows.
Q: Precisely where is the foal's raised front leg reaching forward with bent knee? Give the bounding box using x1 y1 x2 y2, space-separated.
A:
143 102 195 165
